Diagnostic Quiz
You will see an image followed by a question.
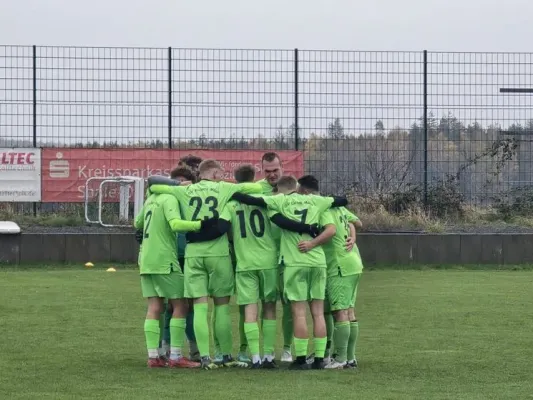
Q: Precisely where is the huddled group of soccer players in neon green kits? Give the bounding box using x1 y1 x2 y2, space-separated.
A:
135 153 363 370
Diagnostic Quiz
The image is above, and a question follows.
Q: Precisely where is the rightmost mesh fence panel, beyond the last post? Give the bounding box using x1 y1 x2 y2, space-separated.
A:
427 53 533 204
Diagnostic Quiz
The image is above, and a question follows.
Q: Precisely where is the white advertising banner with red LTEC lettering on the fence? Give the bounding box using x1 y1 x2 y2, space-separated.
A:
0 148 41 202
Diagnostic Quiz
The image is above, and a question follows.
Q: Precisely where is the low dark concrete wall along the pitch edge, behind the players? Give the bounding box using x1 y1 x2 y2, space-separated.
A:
0 233 533 265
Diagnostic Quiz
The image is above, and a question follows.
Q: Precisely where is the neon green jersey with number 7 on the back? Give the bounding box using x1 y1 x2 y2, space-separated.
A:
264 193 333 268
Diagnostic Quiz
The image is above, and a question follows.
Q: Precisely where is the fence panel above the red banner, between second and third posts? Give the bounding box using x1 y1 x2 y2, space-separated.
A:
172 49 295 150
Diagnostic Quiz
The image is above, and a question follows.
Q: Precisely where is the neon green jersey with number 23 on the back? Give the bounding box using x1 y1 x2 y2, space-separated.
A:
150 180 261 258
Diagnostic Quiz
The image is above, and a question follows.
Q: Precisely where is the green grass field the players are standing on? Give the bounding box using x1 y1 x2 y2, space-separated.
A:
0 267 533 400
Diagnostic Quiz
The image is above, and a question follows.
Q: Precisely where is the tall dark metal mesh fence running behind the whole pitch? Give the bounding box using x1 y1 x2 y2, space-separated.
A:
0 46 533 211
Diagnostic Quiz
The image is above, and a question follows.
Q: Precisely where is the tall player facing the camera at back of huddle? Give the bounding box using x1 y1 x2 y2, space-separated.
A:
257 152 293 362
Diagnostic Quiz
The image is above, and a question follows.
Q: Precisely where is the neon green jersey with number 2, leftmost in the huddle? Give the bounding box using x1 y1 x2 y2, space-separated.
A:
135 194 181 274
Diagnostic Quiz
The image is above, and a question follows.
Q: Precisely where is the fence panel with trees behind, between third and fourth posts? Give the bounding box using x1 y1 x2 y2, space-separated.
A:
299 51 423 196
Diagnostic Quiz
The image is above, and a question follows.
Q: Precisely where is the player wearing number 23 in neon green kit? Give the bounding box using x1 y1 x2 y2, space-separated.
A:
148 160 261 369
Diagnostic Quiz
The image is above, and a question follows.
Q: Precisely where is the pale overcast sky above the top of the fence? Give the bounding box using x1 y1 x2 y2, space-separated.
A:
0 0 533 52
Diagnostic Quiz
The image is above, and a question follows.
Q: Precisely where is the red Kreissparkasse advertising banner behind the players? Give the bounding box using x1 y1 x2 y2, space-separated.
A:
41 149 304 203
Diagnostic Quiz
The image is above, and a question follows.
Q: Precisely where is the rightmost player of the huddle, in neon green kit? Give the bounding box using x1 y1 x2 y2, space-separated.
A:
298 175 362 369
